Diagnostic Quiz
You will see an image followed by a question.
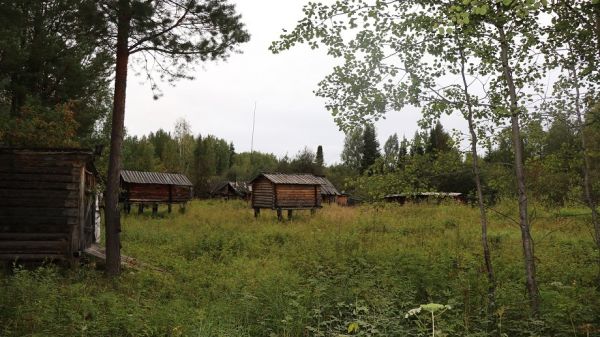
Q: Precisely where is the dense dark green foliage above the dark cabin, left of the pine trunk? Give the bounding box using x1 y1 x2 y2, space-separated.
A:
0 0 112 146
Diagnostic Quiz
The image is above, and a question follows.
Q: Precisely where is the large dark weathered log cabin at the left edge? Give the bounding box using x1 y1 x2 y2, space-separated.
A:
0 148 100 264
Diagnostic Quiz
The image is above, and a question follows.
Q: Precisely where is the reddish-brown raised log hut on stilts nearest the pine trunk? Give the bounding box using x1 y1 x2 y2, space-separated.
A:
120 170 193 214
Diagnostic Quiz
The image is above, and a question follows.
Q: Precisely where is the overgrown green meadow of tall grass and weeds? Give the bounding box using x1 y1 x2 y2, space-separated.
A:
0 200 600 336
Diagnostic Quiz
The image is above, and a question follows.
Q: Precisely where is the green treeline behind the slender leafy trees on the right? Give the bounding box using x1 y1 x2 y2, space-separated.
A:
336 116 600 207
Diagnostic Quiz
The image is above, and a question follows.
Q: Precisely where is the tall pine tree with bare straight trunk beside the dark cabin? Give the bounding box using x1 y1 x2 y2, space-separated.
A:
104 0 250 275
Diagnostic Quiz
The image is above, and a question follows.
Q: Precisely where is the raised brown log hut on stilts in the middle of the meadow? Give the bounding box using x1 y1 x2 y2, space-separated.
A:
250 173 322 220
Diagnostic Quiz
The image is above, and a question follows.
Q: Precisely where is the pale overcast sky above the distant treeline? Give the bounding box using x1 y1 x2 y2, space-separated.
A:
125 0 464 164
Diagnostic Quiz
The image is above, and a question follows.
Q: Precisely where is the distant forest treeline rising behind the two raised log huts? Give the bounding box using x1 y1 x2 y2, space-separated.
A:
123 119 326 197
